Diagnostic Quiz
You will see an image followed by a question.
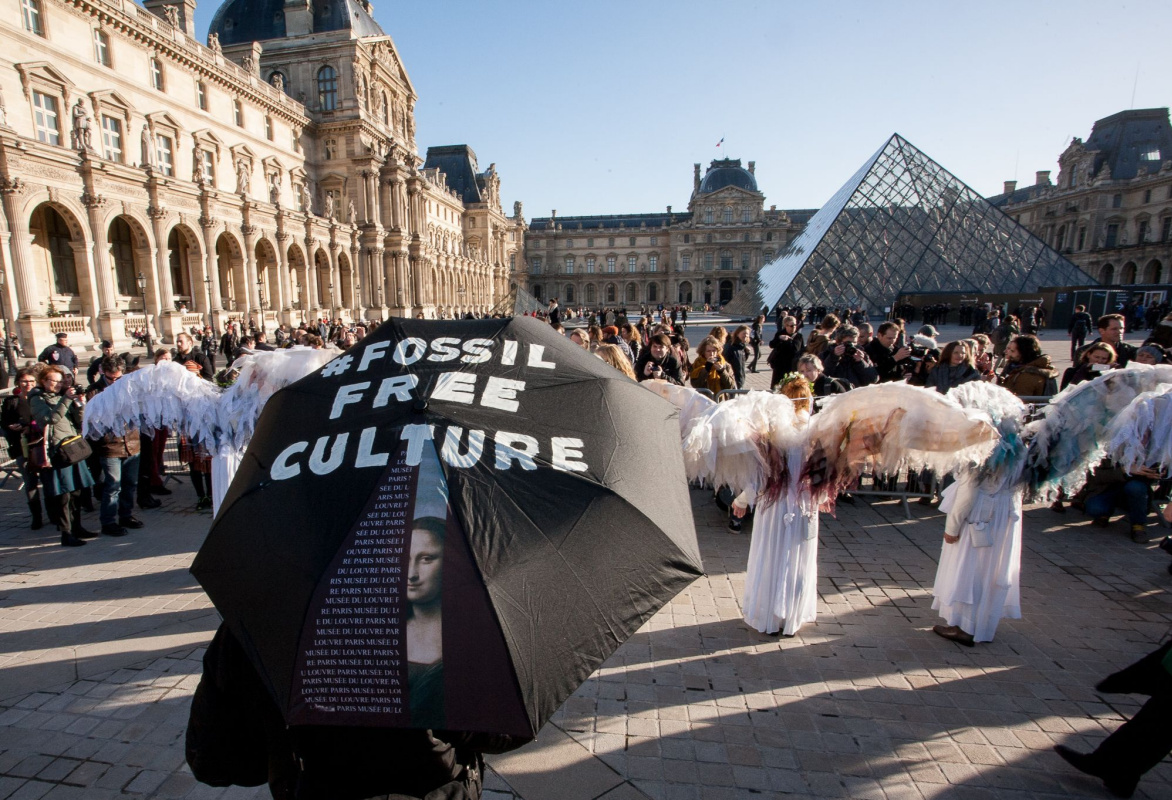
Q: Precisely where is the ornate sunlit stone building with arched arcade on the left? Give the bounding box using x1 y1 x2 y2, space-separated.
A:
0 0 524 350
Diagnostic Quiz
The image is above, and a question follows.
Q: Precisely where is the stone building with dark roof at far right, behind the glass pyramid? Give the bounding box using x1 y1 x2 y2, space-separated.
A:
989 108 1172 301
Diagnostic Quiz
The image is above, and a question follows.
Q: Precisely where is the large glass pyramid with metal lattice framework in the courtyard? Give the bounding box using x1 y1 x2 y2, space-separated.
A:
728 134 1097 314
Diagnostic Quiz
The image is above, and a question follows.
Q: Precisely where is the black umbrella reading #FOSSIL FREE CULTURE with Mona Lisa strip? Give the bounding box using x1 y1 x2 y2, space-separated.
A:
191 317 702 737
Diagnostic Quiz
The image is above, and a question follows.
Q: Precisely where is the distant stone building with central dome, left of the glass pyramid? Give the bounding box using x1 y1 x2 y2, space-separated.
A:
510 158 813 307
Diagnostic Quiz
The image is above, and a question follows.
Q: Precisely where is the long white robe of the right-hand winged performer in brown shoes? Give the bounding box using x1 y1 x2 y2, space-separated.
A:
932 474 1022 642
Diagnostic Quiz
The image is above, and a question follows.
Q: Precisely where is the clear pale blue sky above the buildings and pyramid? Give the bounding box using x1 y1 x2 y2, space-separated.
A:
196 0 1172 218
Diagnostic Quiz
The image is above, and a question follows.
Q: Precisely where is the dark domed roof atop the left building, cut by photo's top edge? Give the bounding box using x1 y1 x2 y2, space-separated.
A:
209 0 386 47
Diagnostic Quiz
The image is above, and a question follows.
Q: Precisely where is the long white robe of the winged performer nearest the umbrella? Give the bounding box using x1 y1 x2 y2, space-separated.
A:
735 447 818 636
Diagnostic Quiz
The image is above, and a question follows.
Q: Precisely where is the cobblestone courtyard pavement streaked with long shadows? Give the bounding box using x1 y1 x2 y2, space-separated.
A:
0 334 1172 800
